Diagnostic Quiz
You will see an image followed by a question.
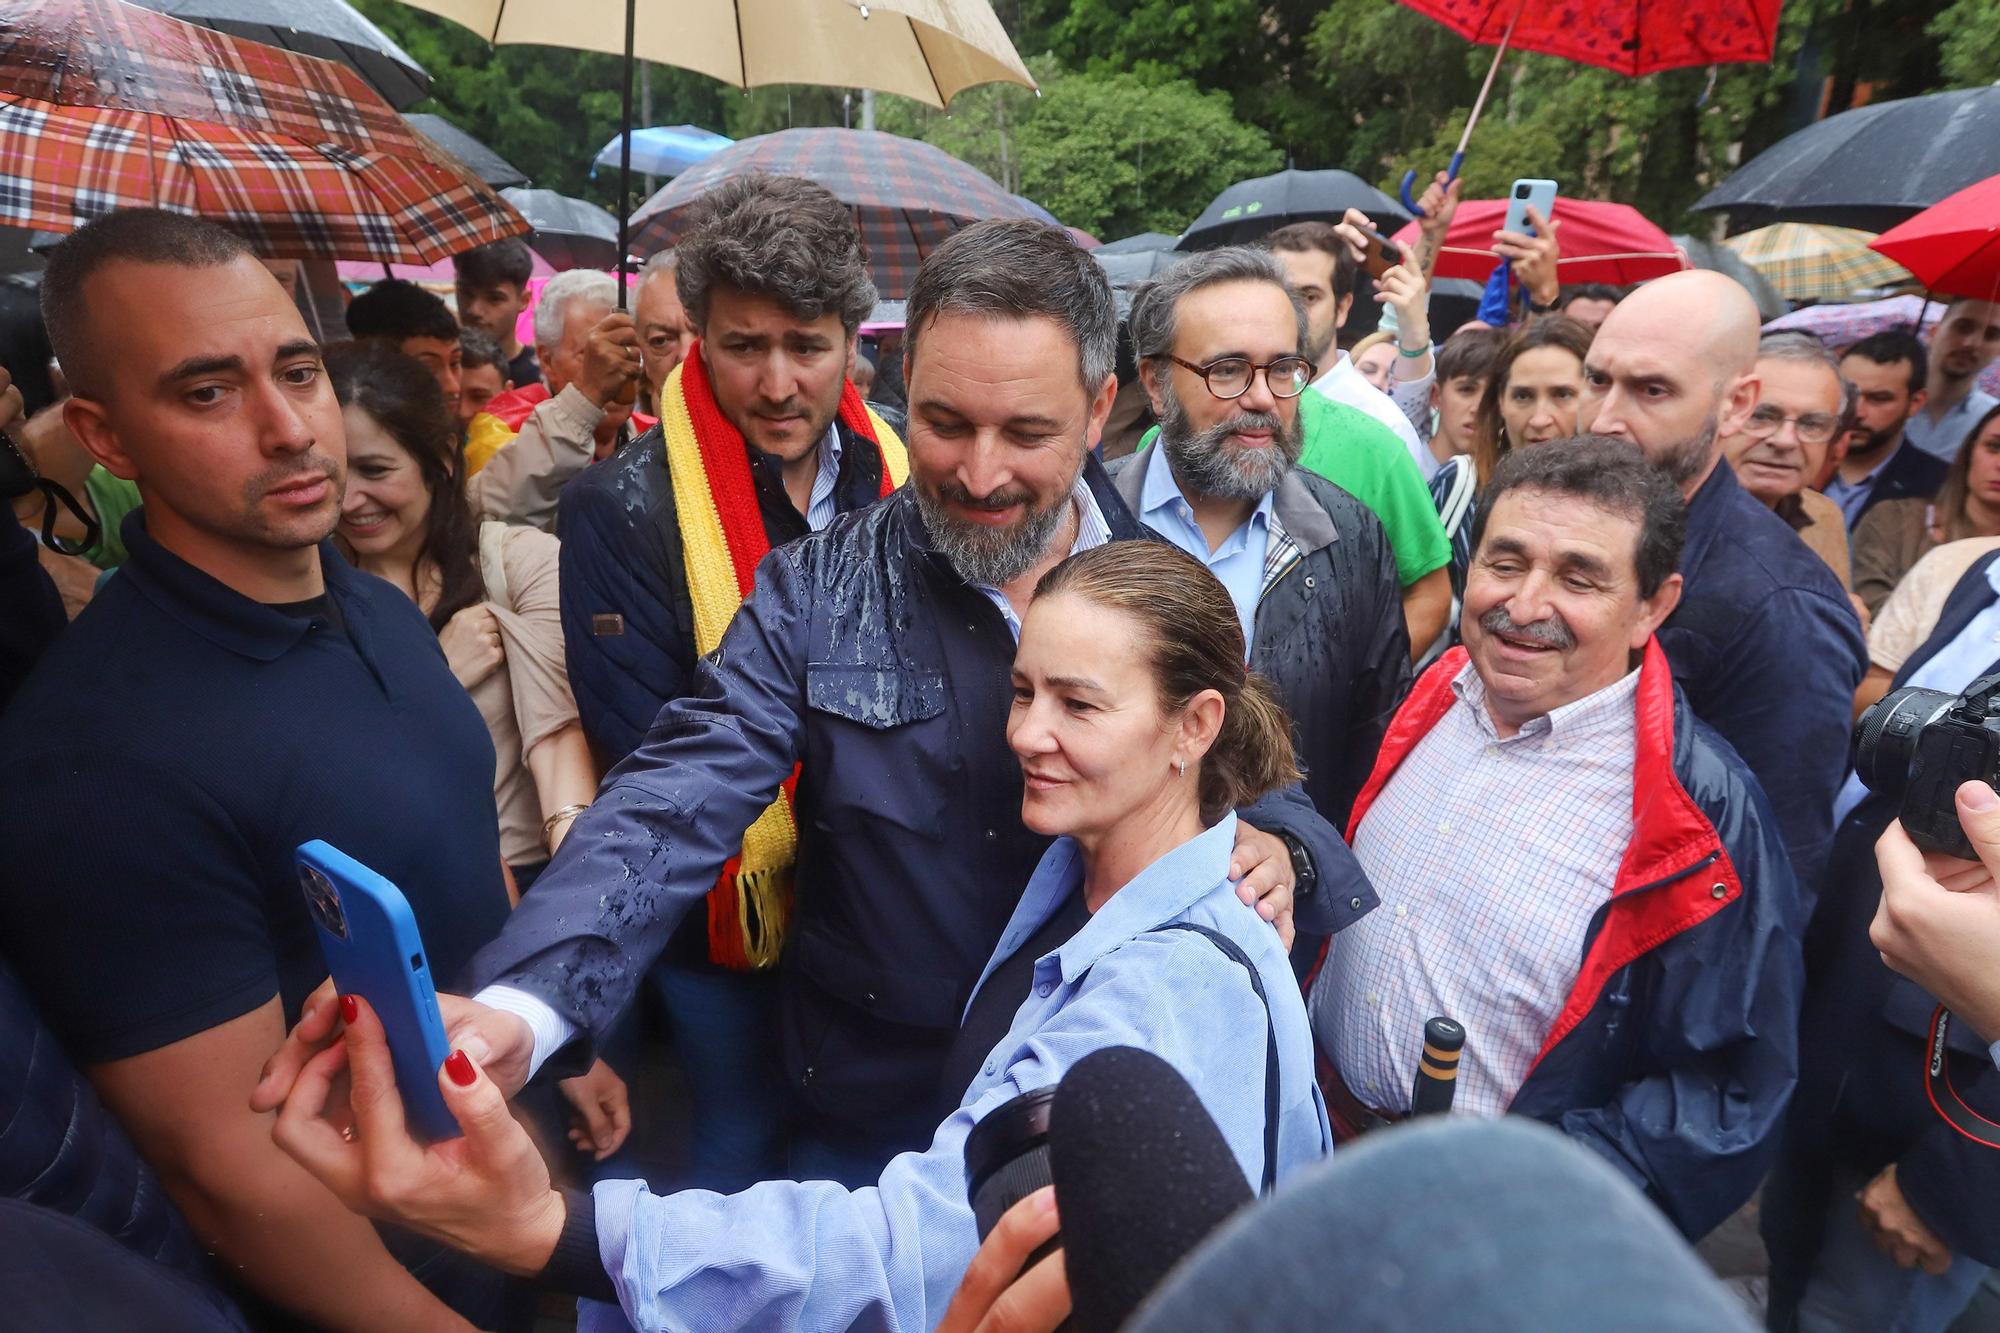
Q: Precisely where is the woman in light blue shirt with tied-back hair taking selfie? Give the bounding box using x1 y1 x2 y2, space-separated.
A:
276 542 1330 1331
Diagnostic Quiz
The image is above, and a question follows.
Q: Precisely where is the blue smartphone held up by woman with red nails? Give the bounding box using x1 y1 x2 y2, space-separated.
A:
296 841 460 1141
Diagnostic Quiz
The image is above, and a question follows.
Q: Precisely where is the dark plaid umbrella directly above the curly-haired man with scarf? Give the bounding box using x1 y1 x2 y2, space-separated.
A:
632 130 1032 300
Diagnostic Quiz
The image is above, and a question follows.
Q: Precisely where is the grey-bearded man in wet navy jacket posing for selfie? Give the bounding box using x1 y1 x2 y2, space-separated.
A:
258 222 1374 1187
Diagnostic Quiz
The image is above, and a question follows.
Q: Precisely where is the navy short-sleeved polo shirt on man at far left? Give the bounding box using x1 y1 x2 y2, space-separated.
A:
0 510 508 1063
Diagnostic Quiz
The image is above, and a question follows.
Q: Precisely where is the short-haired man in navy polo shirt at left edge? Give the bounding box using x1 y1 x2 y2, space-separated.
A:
0 210 508 1329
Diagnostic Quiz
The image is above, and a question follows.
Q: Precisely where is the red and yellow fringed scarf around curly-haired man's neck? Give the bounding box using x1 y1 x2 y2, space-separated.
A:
660 342 910 971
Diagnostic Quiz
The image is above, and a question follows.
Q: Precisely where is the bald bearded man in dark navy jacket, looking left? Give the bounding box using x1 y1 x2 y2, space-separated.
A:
1578 270 1868 892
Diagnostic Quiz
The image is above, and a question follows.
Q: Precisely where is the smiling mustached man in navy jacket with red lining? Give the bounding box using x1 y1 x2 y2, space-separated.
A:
1310 436 1804 1239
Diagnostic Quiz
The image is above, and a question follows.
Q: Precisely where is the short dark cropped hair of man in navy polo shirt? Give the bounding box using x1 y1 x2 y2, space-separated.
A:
42 208 254 398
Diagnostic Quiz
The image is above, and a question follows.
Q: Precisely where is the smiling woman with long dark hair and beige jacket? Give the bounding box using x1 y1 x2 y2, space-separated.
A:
326 342 596 889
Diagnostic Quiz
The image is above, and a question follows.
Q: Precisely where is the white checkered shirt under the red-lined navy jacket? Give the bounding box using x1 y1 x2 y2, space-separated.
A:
1312 664 1638 1115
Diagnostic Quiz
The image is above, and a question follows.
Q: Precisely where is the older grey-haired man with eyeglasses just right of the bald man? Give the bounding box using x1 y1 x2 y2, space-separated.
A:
1722 332 1854 588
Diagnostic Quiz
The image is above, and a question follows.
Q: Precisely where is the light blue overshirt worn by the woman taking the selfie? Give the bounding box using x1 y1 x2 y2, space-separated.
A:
580 815 1332 1333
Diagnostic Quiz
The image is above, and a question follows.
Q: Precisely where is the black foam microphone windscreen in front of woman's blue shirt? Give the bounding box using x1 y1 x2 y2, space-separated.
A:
1048 1047 1252 1333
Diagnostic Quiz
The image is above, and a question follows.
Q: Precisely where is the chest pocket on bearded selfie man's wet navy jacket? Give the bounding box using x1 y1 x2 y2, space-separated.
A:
806 662 960 839
